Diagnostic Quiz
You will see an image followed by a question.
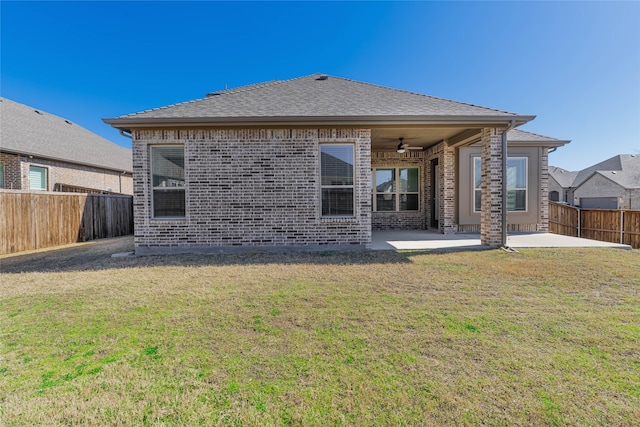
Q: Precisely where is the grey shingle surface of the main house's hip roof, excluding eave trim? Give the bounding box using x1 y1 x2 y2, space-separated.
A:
110 74 530 123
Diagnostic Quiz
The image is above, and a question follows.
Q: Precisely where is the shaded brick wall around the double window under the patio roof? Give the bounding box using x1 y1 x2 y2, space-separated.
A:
371 150 429 230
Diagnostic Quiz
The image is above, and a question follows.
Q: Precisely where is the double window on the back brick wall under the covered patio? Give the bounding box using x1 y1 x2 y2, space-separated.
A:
371 168 420 212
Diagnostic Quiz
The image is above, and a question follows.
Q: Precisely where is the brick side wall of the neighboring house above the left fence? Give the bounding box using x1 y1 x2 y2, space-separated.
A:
0 153 133 194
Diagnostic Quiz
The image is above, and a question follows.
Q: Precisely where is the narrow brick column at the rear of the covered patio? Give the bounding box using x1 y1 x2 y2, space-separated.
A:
438 141 458 234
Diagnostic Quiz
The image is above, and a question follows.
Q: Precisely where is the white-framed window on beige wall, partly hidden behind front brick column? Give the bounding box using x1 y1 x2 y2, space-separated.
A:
473 157 527 212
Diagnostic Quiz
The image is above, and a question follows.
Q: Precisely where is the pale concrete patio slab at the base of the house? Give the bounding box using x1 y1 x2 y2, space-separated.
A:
371 230 631 250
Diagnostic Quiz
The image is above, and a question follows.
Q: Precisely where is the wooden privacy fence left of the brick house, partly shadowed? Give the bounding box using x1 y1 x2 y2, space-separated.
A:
0 190 133 254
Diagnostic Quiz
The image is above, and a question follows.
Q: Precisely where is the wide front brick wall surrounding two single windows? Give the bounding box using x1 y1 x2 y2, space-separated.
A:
133 129 371 253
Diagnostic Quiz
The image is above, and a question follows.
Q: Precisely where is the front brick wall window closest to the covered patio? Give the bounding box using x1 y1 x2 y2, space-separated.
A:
320 144 355 217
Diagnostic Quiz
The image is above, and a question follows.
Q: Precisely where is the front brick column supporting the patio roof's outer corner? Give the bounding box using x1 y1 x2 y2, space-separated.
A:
480 128 507 248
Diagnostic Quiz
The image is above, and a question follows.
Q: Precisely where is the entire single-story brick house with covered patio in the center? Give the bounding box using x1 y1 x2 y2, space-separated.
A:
104 74 568 253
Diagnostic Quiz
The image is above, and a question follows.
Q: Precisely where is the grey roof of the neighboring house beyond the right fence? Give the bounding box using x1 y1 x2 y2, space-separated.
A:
549 154 640 189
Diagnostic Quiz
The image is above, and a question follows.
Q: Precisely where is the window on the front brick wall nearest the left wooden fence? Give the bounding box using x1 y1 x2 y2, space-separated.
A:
151 145 185 218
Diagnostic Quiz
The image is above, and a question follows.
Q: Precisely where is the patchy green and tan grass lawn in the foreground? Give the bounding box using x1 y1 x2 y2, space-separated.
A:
0 249 640 426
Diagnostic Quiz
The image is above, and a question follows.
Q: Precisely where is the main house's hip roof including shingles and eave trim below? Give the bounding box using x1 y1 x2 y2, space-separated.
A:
104 74 534 129
